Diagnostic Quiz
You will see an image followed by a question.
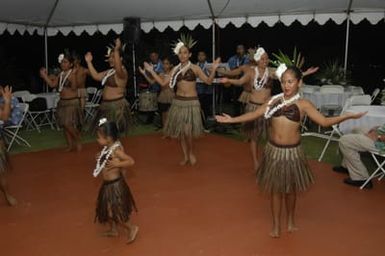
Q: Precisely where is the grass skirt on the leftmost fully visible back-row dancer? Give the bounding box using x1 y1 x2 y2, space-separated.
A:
56 98 83 128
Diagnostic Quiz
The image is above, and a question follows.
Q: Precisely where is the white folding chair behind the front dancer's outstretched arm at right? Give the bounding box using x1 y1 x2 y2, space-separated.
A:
318 95 371 162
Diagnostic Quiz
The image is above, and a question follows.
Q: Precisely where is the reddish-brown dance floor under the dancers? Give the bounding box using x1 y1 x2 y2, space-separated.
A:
0 135 385 256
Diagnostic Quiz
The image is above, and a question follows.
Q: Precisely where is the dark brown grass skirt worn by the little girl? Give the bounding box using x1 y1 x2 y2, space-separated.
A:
95 177 137 223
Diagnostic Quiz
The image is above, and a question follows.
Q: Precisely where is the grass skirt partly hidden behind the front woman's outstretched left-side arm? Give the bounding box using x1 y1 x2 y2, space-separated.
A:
242 101 267 140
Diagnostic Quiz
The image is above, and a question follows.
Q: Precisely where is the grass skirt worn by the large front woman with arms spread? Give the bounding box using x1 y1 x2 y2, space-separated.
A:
257 142 314 194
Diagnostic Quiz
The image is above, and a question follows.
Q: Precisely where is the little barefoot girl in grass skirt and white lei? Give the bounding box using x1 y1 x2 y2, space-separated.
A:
93 118 139 243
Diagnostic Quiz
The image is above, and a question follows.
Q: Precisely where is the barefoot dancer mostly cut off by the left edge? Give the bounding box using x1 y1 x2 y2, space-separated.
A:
0 86 17 206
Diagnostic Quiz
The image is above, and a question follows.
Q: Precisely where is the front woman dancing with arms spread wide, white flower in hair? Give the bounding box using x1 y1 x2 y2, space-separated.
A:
216 65 365 238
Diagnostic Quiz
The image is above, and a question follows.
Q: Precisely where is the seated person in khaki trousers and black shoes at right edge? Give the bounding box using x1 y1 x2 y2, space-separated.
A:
333 124 385 189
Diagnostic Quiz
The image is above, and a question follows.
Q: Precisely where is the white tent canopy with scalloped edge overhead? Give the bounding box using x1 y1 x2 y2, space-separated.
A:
0 0 385 36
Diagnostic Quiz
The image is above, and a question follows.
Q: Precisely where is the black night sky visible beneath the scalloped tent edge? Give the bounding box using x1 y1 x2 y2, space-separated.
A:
0 20 385 93
